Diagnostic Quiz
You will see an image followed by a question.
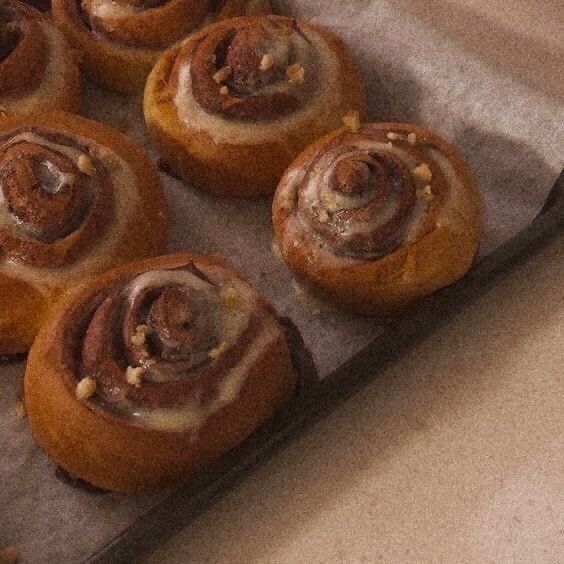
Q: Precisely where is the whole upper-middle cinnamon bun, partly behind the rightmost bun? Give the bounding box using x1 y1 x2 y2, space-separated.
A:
144 16 365 196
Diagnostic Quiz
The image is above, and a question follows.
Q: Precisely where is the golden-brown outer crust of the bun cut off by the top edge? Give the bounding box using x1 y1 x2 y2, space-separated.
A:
52 0 269 92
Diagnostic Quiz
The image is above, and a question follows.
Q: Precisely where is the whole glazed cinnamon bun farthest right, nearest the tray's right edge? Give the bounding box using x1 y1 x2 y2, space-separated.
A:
273 120 481 314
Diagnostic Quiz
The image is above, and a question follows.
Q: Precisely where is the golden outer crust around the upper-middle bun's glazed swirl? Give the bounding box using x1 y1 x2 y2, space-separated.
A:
144 16 366 197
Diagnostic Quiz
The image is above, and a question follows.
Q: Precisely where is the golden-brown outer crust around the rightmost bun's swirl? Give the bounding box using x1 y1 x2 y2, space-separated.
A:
273 123 481 315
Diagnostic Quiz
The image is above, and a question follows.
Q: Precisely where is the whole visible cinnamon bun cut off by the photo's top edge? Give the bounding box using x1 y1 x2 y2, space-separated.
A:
53 0 270 92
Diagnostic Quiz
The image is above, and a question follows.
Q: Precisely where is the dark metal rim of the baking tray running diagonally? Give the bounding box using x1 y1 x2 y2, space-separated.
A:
83 170 564 564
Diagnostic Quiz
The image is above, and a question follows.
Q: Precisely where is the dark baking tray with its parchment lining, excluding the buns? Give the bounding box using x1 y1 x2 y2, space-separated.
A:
0 0 564 562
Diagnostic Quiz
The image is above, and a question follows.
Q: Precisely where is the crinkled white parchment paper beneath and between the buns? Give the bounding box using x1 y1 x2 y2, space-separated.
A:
0 0 564 562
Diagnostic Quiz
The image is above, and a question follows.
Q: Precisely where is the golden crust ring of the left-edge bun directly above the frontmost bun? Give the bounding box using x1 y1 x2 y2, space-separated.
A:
0 112 166 354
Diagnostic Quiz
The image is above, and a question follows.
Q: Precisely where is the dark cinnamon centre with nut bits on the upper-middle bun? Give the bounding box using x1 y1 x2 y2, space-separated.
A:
184 18 319 121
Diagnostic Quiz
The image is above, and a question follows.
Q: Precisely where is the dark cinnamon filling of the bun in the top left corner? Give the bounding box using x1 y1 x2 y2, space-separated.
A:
0 0 49 98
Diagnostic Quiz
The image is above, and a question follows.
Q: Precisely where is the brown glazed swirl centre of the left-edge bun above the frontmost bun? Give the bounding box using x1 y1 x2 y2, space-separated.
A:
0 130 115 268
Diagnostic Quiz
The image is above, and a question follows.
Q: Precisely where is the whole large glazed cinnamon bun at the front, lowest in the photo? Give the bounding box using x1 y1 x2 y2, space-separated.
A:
24 254 313 492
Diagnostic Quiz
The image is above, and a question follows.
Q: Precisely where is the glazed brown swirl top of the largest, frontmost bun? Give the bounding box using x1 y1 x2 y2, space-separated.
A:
66 262 283 431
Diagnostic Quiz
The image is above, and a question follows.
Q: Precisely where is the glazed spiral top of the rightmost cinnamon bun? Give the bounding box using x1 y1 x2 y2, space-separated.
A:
274 125 472 260
